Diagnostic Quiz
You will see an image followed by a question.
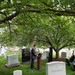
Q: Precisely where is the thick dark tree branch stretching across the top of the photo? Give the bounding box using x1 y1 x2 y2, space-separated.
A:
0 8 75 24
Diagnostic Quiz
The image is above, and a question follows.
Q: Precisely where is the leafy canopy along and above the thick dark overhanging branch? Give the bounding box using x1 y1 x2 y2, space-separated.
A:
0 0 75 24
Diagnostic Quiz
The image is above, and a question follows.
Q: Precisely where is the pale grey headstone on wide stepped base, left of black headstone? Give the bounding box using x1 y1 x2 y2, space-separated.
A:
6 54 20 67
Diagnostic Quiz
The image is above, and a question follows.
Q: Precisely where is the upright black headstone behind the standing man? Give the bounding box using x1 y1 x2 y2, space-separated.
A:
22 48 30 63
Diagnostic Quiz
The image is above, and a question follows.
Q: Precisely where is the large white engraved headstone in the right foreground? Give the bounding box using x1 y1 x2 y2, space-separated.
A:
46 61 66 75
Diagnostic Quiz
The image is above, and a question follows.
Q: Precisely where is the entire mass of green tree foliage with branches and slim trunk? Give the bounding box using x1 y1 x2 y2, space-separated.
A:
0 0 75 58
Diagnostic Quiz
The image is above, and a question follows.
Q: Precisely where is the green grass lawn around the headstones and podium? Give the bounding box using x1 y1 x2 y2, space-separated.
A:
0 52 75 75
